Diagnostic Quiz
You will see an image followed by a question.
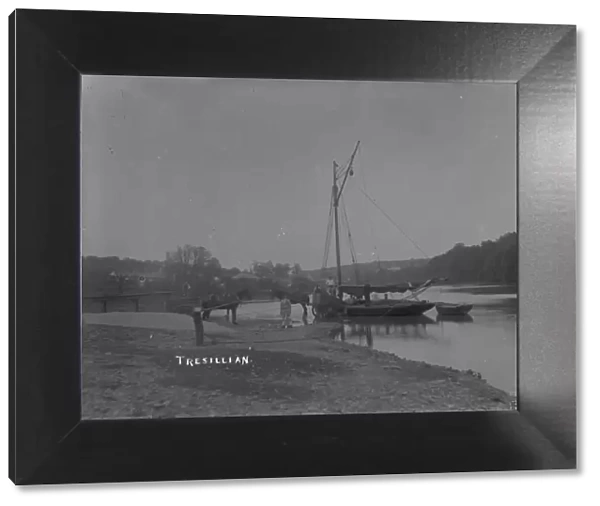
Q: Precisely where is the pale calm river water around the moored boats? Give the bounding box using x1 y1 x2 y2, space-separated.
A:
234 285 517 395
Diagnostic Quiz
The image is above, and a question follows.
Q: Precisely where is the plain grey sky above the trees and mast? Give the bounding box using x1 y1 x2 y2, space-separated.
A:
82 76 517 269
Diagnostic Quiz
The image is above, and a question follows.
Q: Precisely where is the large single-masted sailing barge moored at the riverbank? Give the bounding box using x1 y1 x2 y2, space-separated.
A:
313 141 439 317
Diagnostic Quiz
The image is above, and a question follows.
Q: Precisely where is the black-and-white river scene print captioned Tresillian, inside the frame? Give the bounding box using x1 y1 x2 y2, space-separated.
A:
81 76 518 419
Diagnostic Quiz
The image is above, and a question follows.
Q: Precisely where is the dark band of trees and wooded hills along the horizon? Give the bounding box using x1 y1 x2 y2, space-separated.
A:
82 232 518 297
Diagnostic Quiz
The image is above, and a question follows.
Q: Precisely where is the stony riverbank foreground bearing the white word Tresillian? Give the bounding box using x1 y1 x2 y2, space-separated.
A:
83 317 511 418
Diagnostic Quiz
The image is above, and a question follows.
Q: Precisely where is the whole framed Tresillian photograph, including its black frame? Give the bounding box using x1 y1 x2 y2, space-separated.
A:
9 6 577 484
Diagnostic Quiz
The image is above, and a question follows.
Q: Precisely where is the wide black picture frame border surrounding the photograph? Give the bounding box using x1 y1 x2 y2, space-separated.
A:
9 10 577 485
